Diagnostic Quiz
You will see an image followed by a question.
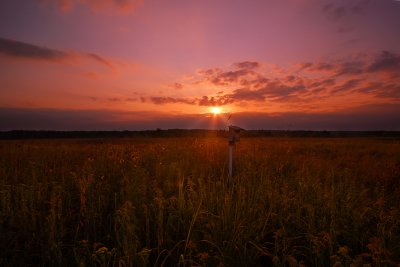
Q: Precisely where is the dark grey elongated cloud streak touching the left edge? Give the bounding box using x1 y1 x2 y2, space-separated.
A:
0 37 69 61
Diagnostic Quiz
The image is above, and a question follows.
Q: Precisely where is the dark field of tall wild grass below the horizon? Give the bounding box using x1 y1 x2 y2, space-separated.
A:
0 137 400 267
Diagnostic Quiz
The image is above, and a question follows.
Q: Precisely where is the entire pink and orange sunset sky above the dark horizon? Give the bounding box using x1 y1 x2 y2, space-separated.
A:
0 0 400 131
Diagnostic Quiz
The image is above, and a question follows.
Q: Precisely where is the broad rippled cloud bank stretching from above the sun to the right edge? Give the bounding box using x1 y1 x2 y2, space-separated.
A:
186 51 400 106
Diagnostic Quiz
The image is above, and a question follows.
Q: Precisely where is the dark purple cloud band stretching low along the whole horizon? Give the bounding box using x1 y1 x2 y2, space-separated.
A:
0 105 400 131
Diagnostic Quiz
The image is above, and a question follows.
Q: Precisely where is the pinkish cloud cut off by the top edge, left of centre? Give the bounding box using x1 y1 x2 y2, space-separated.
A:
39 0 143 14
